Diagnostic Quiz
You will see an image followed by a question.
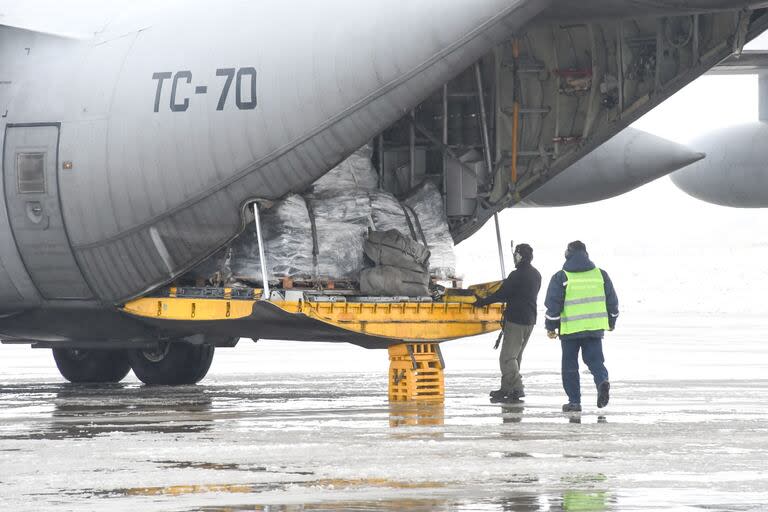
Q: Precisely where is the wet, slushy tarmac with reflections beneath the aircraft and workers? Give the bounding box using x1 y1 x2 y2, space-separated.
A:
0 322 768 512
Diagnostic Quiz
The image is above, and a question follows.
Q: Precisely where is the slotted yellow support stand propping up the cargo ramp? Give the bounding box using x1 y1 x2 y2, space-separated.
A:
389 343 445 402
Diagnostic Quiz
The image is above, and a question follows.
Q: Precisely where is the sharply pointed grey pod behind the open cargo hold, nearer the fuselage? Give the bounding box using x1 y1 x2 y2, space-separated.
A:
519 128 705 207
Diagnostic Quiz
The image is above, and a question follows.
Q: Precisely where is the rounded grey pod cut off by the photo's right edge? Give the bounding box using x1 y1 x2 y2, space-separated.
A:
672 122 768 208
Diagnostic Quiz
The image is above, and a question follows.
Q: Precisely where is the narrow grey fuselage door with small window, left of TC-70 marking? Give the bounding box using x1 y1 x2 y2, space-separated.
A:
3 124 93 299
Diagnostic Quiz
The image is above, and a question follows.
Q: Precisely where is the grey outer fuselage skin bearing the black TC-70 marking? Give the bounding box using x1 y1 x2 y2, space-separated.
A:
0 0 761 346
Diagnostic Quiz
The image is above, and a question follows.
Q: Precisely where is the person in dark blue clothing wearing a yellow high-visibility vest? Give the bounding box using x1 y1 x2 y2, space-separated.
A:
544 241 619 412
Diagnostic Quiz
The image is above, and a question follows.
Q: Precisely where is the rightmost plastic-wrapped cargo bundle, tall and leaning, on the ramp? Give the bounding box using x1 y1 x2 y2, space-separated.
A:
405 181 456 279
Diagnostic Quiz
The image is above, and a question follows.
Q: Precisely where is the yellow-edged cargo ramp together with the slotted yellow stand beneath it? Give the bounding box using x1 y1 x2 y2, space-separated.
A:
122 283 502 401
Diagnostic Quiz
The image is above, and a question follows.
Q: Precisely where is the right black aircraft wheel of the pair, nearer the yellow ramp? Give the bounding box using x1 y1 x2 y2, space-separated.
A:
128 342 215 386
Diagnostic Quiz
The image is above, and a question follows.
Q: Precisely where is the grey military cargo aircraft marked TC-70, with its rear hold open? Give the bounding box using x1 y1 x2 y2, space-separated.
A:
0 0 768 384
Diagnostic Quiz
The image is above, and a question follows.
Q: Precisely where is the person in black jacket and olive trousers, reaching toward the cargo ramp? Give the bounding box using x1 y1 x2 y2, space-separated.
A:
475 244 541 403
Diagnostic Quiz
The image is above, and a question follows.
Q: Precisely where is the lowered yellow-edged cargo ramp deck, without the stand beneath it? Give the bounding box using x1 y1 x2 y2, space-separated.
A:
122 288 502 348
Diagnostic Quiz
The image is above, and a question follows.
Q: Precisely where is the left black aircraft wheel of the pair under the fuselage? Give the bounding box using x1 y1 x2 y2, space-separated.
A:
53 348 131 384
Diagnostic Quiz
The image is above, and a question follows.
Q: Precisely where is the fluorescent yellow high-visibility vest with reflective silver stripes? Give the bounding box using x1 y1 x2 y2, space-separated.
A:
560 268 608 335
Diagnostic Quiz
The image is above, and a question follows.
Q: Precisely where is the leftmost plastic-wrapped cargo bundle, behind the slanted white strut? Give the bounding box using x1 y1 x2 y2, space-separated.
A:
231 194 314 282
